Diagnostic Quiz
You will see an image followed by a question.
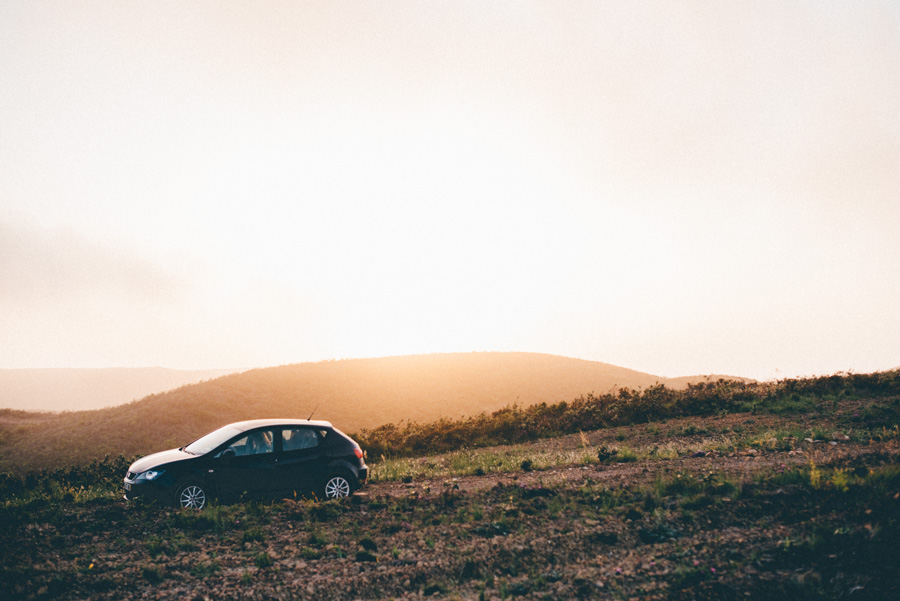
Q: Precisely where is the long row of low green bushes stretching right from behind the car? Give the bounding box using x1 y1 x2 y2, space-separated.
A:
354 370 900 462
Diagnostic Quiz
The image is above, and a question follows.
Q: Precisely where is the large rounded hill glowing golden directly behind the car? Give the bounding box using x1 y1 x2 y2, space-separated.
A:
0 353 752 471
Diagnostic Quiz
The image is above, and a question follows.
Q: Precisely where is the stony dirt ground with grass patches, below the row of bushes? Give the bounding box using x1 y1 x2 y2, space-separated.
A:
0 407 900 600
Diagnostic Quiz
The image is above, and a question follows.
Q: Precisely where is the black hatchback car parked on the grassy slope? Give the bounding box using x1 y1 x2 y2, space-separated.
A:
125 419 369 509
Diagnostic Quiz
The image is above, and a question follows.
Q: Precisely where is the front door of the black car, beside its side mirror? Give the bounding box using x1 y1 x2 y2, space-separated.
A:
209 428 278 499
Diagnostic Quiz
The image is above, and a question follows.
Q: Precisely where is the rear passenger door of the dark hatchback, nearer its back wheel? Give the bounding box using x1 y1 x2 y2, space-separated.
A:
276 426 326 495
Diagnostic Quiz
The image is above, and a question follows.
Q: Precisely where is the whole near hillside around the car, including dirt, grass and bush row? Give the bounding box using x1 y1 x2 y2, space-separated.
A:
0 371 900 601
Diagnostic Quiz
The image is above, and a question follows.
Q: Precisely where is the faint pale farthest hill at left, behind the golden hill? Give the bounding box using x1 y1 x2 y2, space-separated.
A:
0 367 239 411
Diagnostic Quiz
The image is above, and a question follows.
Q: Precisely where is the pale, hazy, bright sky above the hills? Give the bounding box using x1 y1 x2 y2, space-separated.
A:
0 0 900 378
